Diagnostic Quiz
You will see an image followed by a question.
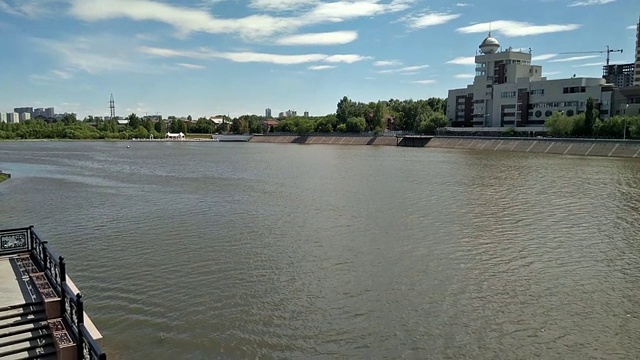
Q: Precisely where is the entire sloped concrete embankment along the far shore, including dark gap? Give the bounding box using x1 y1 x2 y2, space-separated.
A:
250 135 640 158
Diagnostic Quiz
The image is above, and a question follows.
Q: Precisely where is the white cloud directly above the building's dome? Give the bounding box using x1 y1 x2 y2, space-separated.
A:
456 20 581 37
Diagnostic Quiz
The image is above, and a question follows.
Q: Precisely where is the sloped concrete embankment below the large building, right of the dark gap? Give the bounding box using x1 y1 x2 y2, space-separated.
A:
426 137 640 158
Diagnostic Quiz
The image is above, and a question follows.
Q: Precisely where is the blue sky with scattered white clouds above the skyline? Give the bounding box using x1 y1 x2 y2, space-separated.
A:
0 0 640 117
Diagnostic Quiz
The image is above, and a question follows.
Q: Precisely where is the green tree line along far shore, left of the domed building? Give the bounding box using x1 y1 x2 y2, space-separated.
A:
0 96 447 140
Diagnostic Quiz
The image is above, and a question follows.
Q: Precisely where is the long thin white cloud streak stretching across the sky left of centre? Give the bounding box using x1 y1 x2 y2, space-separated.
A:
140 46 369 65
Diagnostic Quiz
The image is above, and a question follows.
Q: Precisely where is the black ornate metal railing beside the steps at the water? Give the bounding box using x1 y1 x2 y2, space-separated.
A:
0 226 107 360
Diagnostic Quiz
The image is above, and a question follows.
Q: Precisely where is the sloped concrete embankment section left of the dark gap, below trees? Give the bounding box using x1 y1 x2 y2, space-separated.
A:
250 135 397 146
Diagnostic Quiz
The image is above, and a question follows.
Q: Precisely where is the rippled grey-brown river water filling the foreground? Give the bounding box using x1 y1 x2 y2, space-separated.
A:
0 142 640 359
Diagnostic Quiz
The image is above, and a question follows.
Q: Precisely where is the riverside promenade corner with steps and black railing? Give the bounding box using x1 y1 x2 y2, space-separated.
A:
0 226 107 360
